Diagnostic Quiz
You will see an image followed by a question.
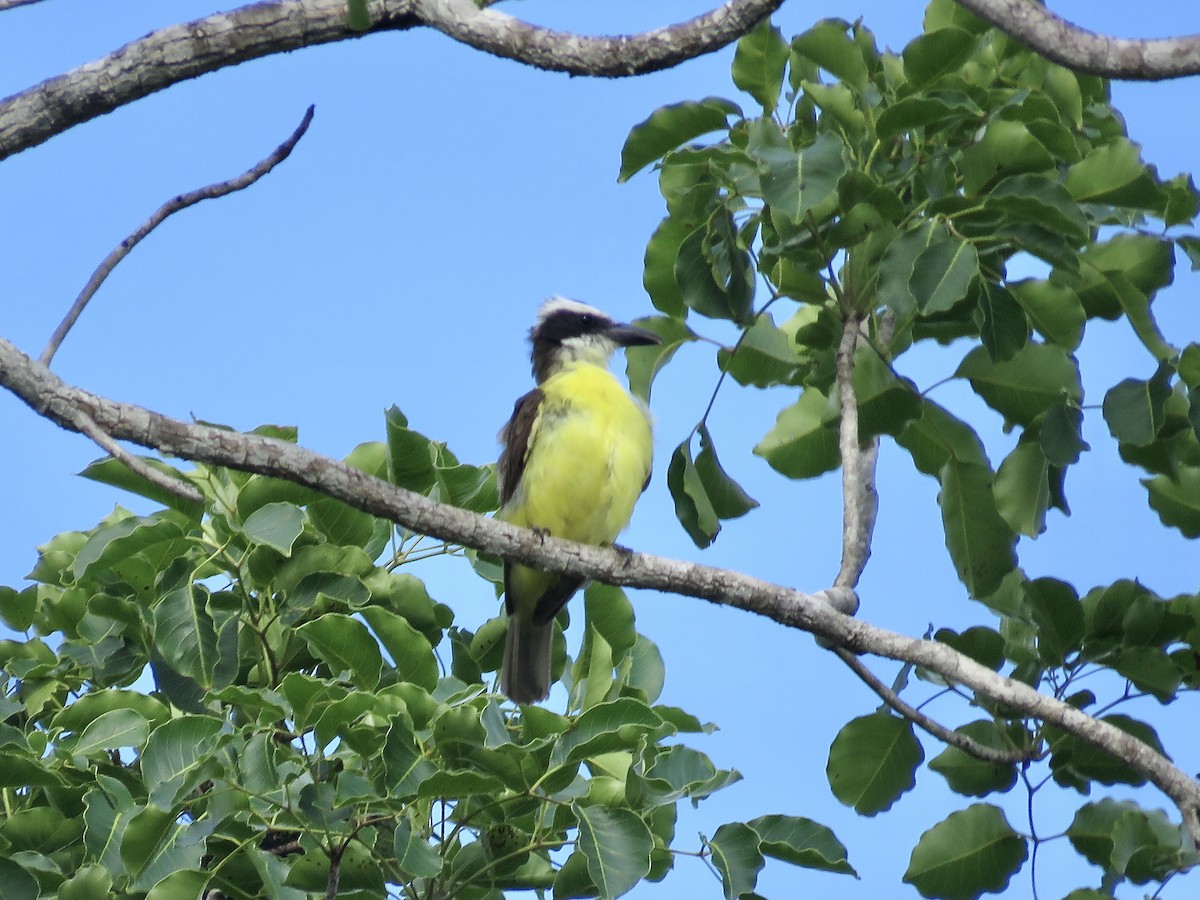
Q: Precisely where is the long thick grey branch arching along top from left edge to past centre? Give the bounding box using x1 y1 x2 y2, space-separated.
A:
0 0 782 160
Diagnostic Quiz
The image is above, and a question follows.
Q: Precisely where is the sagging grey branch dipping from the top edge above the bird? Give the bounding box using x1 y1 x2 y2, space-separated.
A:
413 0 784 78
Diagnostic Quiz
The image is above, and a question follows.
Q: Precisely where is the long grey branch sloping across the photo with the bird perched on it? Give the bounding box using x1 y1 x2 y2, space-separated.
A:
0 338 1200 841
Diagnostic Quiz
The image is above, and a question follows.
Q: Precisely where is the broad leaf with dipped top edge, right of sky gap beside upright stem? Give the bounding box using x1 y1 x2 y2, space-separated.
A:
954 343 1084 425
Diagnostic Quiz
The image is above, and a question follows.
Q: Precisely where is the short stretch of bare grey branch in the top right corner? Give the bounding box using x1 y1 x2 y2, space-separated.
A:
956 0 1200 82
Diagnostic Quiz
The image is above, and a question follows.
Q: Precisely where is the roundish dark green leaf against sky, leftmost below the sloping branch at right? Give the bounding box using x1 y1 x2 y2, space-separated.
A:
826 712 925 816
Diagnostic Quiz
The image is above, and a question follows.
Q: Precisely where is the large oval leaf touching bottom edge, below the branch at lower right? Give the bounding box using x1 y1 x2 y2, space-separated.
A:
904 803 1028 900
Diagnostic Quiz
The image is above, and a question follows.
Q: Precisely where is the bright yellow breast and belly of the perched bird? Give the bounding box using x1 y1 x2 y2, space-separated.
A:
503 362 653 544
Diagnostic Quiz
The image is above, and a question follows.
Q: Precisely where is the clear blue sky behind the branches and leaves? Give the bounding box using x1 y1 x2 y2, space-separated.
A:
0 0 1200 898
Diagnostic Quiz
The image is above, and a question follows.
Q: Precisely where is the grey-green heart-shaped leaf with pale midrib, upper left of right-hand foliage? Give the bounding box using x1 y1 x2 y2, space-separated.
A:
746 119 846 224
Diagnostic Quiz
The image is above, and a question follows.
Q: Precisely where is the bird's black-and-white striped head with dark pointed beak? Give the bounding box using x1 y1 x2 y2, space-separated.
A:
529 296 661 384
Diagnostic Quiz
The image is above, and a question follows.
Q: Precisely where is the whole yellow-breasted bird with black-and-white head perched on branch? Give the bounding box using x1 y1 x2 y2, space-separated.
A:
497 296 661 704
